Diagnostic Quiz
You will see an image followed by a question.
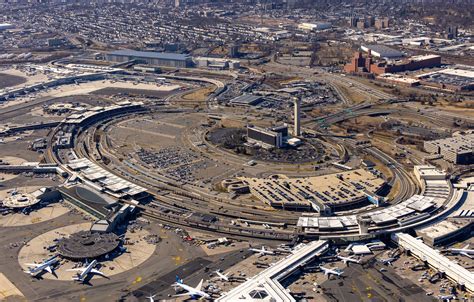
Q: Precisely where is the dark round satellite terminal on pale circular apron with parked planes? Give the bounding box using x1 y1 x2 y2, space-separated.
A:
58 231 120 260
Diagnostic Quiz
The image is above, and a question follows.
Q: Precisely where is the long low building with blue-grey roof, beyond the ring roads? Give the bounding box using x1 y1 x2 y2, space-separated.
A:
106 49 193 68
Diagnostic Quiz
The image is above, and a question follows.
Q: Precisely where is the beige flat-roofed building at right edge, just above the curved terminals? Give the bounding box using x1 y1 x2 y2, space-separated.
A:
423 133 474 165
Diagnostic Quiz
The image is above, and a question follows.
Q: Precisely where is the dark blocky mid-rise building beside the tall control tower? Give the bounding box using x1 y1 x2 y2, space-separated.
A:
247 124 288 148
